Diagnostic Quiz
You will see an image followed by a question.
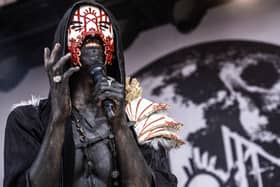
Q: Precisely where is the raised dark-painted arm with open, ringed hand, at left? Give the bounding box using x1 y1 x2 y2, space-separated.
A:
29 44 79 187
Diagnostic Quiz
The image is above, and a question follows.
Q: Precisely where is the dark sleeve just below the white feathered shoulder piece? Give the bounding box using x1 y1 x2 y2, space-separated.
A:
140 145 177 187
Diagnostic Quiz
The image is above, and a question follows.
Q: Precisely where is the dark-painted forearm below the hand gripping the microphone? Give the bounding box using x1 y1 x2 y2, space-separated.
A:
112 117 153 187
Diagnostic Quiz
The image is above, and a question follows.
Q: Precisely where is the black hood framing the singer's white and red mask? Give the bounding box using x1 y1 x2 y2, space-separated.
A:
54 0 125 85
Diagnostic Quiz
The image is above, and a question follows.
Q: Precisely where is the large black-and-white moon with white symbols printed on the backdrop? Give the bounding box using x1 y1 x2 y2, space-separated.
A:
135 40 280 187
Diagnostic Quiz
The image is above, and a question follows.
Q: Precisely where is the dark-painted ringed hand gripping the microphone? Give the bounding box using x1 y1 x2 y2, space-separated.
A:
93 77 124 118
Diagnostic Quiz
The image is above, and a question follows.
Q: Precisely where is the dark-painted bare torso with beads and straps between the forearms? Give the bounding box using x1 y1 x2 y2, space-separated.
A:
72 113 113 187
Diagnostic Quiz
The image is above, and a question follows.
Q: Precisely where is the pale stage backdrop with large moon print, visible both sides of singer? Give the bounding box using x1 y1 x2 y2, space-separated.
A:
0 0 280 187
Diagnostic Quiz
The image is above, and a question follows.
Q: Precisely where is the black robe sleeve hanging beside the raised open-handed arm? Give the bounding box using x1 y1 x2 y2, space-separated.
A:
4 108 40 187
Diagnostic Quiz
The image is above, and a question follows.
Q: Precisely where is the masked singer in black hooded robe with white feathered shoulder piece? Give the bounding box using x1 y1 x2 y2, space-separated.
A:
4 1 183 187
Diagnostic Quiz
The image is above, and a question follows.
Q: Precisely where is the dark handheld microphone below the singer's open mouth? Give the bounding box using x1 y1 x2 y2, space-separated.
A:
89 61 115 119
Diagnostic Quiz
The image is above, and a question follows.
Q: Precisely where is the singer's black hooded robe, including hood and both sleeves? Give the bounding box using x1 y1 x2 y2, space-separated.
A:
4 1 177 187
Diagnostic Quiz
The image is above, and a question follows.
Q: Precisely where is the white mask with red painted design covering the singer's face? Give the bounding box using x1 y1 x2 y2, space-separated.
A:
67 5 114 66
